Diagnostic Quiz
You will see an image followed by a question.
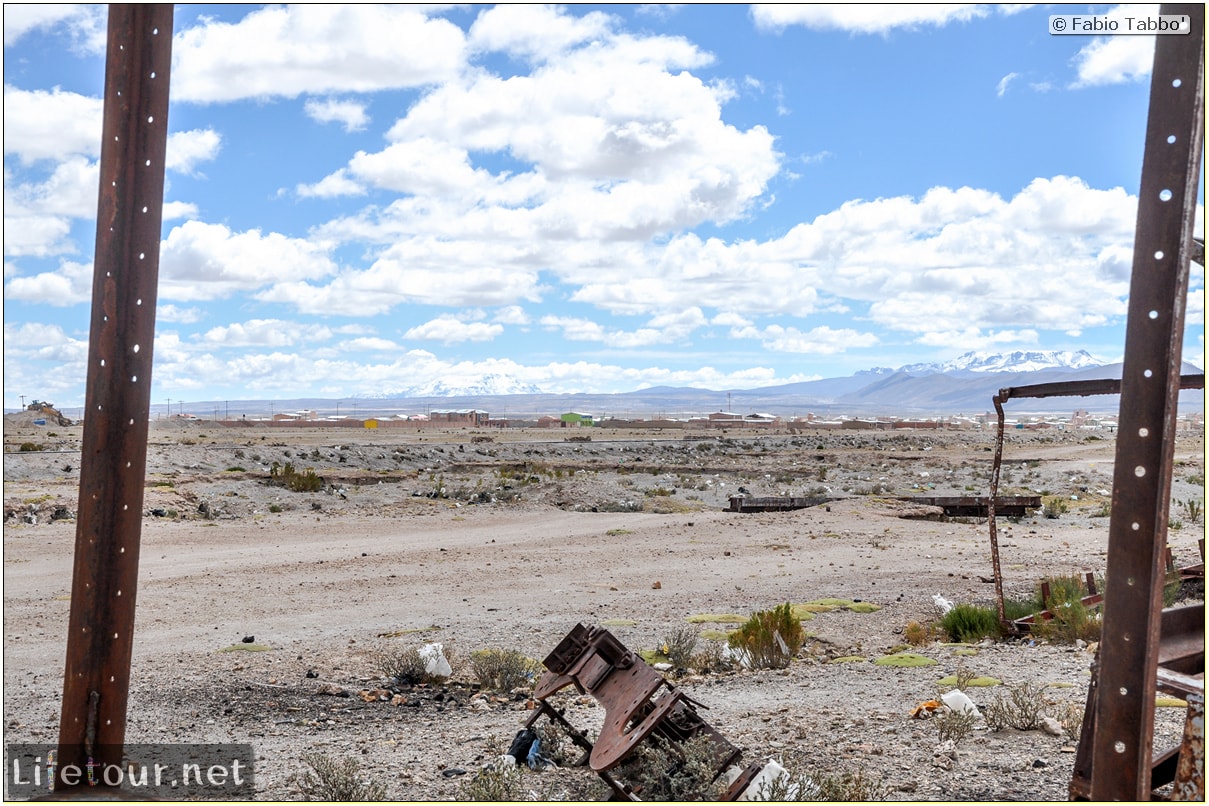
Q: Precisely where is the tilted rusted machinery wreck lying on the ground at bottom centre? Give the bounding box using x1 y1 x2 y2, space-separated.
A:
525 624 763 800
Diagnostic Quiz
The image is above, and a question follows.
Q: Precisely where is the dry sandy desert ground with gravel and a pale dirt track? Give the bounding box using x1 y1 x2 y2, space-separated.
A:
4 414 1204 801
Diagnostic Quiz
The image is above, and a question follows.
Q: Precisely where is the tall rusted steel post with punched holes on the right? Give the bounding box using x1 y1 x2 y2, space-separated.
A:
1091 4 1204 801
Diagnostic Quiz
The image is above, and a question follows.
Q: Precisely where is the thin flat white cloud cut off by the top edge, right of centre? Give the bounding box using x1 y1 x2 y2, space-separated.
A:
752 2 990 34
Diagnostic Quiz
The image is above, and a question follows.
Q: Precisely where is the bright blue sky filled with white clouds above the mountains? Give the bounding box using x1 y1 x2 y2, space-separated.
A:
4 5 1204 408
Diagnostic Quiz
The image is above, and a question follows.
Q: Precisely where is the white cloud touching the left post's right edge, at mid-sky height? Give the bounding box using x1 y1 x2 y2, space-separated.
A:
160 221 336 301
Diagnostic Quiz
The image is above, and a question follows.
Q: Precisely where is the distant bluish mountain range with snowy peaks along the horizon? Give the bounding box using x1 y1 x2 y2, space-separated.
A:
207 350 1204 419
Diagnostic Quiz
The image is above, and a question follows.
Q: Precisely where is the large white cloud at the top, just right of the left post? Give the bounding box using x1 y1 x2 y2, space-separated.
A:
172 4 464 103
